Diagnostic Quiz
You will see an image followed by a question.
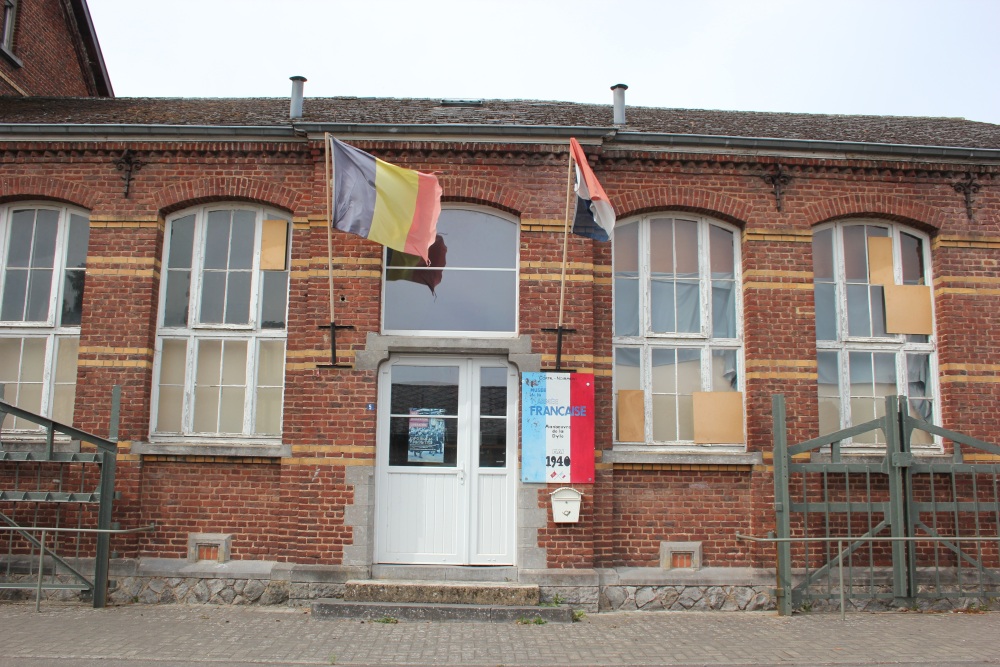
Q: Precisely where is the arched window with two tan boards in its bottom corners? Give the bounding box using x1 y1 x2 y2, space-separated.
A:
614 213 745 447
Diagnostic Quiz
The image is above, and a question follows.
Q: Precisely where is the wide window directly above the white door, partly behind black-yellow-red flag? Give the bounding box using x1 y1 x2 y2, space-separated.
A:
382 208 518 336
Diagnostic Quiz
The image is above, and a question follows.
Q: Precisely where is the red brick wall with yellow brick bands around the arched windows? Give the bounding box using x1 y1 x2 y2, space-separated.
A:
0 133 1000 568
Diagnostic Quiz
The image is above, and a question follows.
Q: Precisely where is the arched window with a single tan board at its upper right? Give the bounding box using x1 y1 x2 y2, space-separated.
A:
152 205 291 442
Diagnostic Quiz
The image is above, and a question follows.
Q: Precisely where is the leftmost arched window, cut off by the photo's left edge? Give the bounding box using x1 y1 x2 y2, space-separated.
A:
0 203 90 431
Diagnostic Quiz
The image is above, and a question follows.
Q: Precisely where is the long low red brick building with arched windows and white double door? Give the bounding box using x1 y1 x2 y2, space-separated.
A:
0 3 1000 608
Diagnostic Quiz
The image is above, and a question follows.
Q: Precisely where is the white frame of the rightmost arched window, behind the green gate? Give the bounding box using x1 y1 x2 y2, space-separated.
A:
813 218 942 453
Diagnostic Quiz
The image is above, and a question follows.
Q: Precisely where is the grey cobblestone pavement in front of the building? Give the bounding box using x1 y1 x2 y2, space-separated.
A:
0 603 1000 667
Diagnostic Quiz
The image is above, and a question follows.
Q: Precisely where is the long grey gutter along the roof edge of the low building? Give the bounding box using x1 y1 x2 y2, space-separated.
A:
0 122 1000 161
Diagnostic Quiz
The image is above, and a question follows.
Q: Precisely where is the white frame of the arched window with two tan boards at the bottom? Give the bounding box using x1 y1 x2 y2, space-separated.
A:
612 211 746 453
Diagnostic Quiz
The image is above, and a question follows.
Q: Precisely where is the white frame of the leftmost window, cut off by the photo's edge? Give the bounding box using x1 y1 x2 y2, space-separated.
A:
0 201 90 439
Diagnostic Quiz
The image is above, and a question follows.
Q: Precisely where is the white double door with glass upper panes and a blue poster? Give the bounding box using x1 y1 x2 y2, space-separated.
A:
375 357 518 565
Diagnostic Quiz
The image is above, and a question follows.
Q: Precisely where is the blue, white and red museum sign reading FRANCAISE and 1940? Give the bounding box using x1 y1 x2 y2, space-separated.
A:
521 373 594 484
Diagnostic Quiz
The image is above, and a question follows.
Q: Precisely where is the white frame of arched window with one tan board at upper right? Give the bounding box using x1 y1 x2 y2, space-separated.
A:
150 202 292 444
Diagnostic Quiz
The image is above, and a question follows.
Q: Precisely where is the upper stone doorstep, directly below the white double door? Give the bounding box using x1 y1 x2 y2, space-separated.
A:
344 580 541 607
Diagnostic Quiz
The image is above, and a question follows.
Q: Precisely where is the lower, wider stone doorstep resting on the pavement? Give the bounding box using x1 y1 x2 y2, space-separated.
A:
312 598 573 623
